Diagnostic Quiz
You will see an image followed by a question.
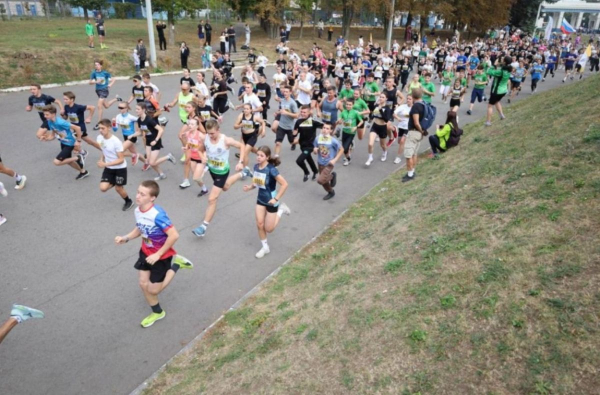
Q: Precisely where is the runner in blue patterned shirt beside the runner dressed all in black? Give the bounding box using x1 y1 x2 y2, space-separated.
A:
313 123 344 200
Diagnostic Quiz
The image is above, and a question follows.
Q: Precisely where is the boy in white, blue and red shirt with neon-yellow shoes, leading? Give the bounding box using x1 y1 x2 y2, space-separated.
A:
115 180 194 328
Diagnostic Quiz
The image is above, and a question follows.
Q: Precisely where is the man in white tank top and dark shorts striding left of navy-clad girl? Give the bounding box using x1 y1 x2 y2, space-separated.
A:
192 120 250 237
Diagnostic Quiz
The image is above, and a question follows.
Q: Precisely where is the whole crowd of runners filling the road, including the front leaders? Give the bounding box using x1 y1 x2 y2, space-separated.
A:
0 26 598 327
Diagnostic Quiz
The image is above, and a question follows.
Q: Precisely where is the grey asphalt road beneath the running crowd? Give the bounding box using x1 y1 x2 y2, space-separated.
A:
0 63 572 395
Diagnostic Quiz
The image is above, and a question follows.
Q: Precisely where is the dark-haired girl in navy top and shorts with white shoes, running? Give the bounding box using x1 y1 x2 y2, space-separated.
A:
244 145 291 259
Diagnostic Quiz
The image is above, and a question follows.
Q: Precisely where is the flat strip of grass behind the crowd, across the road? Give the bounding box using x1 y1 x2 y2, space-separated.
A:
0 18 450 89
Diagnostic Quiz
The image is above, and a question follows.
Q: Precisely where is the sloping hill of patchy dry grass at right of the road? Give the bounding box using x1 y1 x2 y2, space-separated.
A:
146 77 600 394
